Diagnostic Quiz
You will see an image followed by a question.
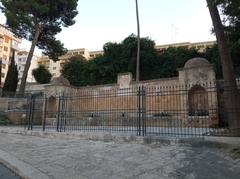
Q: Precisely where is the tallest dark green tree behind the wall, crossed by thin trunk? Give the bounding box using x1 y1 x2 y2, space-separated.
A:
104 34 159 81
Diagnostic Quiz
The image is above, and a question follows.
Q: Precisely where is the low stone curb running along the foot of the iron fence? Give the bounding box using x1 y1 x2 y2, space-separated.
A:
0 128 240 147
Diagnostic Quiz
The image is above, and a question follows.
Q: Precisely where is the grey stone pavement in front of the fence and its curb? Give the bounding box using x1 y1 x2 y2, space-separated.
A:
0 133 240 179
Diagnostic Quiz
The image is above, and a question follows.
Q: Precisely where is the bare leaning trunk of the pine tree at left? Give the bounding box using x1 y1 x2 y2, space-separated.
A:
19 27 40 95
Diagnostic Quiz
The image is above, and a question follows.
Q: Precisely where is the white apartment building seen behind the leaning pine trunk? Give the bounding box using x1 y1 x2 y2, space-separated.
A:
15 50 39 84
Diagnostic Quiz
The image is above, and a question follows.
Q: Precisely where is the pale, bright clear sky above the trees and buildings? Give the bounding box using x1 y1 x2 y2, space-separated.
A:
0 0 215 54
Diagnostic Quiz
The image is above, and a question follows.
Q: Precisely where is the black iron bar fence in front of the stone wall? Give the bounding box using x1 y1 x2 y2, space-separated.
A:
22 82 240 137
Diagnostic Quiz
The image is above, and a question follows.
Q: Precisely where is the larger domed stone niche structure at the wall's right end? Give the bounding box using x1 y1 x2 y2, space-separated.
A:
178 57 218 127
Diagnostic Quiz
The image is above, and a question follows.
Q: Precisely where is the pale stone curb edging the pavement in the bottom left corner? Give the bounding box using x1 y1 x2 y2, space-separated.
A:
0 150 50 179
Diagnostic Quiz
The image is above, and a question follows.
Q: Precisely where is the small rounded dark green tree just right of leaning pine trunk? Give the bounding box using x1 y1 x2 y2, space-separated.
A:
32 65 52 84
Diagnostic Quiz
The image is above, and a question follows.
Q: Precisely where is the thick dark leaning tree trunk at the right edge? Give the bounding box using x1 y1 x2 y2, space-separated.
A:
207 0 240 135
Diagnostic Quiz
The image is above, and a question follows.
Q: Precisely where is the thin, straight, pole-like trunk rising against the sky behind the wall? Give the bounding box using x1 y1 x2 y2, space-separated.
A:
136 0 140 83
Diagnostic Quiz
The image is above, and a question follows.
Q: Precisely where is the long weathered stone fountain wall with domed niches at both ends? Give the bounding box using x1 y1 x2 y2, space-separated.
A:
21 58 223 127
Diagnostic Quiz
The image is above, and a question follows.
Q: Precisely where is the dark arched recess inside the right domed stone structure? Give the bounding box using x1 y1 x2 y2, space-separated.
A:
188 85 209 116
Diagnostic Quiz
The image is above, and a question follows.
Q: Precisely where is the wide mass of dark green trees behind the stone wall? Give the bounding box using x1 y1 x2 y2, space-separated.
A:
62 34 204 86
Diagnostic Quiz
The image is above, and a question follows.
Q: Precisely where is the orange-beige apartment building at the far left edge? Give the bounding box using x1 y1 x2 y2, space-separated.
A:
0 24 21 87
